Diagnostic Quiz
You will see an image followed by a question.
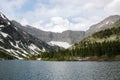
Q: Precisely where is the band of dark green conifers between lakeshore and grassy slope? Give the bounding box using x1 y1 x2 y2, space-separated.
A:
42 40 120 61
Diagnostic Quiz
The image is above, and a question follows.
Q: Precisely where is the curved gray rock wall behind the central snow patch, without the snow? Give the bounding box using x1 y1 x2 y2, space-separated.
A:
12 21 85 44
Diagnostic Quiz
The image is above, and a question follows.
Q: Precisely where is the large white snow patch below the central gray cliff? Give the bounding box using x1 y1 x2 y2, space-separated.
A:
48 41 72 49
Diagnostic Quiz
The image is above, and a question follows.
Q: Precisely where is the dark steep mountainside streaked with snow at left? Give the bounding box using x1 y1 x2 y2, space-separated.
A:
0 13 59 59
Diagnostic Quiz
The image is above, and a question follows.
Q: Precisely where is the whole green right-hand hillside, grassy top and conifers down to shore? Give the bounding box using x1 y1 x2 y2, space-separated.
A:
41 20 120 61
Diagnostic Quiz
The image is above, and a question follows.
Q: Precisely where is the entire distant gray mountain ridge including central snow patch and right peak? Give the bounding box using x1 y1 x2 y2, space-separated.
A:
12 15 120 48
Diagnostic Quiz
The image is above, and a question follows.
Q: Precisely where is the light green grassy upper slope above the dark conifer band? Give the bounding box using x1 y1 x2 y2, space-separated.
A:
70 19 120 49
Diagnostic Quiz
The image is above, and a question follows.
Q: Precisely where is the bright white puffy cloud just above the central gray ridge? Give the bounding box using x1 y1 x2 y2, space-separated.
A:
39 17 98 32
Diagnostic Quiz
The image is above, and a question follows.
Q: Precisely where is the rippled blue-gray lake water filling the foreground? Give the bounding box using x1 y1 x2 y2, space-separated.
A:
0 60 120 80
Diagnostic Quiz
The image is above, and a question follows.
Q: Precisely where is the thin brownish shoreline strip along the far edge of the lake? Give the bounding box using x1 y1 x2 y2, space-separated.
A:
0 55 120 62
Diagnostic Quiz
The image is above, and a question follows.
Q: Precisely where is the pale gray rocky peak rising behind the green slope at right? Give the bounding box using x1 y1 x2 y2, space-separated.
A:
85 15 120 37
